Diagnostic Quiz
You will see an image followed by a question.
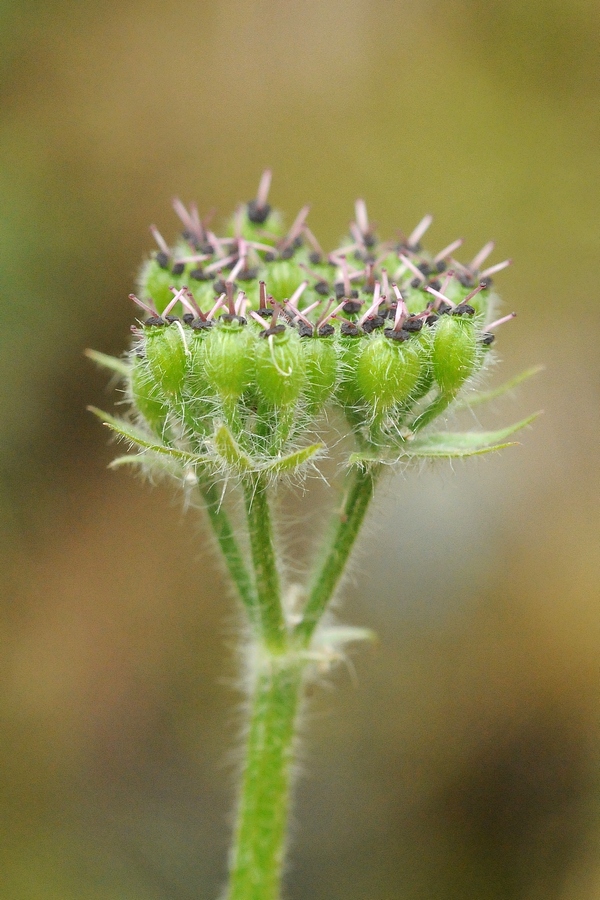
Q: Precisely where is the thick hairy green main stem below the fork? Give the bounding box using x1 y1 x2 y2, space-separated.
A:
226 656 304 900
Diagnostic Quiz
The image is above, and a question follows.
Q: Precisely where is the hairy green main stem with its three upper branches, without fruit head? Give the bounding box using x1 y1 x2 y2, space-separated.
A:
201 466 381 900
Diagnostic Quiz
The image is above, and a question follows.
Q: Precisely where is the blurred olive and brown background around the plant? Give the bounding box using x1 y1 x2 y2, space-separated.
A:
0 0 600 900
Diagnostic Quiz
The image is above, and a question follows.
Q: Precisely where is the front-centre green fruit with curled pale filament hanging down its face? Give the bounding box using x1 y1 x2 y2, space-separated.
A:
255 326 306 408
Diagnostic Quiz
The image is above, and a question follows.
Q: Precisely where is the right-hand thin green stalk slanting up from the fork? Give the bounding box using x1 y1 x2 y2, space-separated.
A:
295 465 382 646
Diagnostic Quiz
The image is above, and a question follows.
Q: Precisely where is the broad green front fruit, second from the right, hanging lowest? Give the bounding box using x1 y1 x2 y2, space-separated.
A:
356 334 422 418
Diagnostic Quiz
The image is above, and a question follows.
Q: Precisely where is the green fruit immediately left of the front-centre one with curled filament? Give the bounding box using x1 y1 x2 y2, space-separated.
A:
201 320 254 403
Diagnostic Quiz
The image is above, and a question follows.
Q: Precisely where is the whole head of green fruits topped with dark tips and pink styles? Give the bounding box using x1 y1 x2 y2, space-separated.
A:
125 172 510 459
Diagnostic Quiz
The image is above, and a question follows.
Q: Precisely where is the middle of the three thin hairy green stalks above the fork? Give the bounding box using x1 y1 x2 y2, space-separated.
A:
244 475 287 653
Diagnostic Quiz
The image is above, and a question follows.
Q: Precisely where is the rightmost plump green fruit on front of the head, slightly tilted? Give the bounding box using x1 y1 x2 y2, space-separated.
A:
431 316 479 395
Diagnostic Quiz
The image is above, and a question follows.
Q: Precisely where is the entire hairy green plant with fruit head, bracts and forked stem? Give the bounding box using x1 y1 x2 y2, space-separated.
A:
89 172 533 900
